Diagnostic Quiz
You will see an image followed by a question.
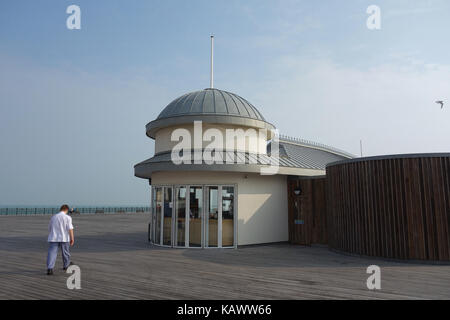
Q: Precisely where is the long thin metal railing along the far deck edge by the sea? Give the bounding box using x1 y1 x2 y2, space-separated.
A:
0 207 151 216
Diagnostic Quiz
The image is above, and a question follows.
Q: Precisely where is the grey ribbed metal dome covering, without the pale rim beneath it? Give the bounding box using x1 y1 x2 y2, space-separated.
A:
157 88 265 121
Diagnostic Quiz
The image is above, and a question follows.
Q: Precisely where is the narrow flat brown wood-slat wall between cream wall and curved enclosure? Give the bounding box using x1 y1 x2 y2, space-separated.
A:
288 177 328 245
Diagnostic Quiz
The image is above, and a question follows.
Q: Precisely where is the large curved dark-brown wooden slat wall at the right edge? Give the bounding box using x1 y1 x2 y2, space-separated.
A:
326 156 450 261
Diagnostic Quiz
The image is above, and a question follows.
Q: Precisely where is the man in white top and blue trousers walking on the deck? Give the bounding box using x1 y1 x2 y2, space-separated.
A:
47 204 75 275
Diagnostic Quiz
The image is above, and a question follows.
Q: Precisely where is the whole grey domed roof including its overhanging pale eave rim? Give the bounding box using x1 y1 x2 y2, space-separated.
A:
146 88 275 139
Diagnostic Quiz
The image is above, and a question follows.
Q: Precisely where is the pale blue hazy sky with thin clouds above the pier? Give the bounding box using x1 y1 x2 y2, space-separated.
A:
0 0 450 206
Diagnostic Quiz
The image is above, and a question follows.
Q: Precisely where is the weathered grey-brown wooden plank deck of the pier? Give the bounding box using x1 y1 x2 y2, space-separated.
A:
0 214 450 299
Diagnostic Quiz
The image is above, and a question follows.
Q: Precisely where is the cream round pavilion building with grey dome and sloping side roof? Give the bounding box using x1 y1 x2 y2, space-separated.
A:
134 88 352 248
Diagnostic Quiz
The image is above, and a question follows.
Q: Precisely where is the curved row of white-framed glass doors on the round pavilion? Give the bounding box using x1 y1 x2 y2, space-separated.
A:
149 185 236 248
